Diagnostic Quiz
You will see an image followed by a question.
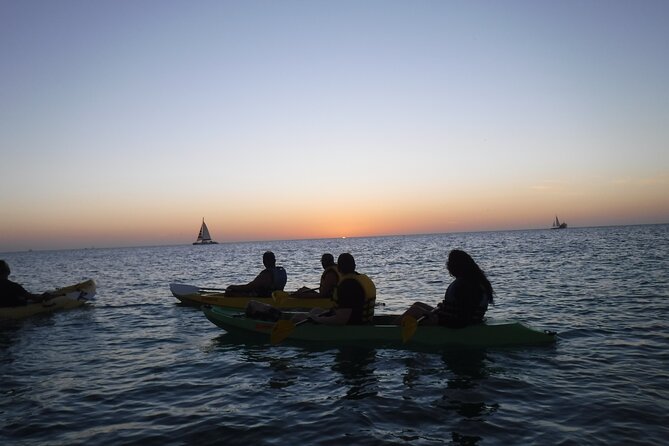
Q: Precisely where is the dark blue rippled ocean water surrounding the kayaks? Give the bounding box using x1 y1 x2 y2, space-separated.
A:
0 225 669 445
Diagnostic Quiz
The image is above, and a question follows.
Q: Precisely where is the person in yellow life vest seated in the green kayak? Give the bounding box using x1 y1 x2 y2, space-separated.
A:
293 253 376 325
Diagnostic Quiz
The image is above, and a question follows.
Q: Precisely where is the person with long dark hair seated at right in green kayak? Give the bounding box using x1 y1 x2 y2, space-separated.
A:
402 249 493 328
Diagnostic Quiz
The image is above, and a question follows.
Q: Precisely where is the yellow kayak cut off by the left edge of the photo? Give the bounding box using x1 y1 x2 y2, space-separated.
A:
0 280 96 319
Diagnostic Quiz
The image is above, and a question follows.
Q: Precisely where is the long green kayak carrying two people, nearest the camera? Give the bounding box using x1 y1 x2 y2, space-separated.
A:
202 306 556 348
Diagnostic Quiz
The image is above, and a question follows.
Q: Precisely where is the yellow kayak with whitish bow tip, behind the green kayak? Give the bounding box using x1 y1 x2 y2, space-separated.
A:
170 284 333 309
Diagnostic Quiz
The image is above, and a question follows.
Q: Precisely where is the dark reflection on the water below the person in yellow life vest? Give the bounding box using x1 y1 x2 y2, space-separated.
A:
332 347 379 400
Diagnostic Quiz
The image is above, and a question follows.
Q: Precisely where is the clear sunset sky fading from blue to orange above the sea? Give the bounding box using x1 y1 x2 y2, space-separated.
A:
0 0 669 252
